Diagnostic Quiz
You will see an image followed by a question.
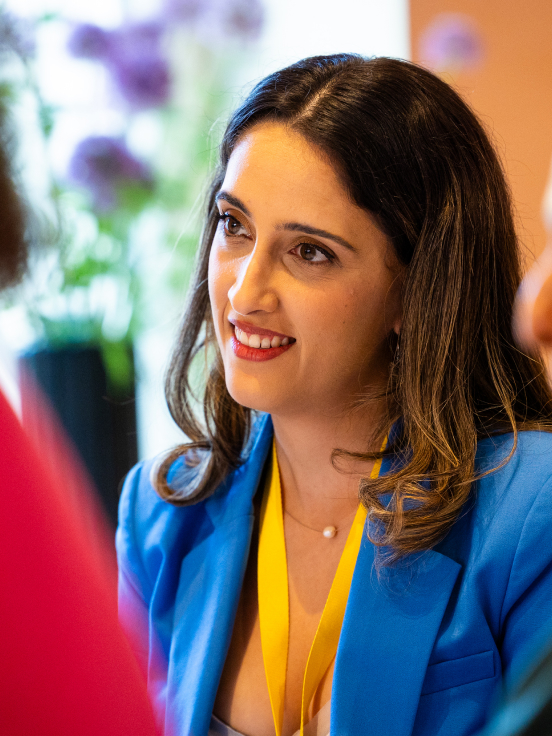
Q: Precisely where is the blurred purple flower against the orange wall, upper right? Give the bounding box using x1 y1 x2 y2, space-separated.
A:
420 13 484 71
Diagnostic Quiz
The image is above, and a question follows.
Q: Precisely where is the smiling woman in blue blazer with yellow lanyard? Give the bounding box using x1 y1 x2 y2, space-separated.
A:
117 55 552 736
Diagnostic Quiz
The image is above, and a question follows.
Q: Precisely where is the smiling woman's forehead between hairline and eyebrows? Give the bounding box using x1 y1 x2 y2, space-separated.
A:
222 123 360 220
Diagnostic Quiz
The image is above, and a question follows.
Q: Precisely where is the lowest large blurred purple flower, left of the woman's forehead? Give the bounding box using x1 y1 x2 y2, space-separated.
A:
69 136 153 212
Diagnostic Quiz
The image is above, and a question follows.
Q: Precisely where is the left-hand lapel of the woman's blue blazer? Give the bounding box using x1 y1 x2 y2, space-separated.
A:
167 417 272 736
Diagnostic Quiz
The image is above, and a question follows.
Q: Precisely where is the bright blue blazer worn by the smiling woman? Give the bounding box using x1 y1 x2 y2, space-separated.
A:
117 415 552 736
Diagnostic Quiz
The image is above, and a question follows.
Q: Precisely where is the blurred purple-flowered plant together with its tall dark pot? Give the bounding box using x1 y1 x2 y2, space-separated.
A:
0 0 263 519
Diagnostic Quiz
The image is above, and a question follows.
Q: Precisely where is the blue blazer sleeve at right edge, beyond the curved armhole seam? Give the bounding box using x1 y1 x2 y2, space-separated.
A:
500 478 552 671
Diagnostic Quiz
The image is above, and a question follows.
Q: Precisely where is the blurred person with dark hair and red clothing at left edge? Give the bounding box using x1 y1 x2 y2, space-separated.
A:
0 89 155 736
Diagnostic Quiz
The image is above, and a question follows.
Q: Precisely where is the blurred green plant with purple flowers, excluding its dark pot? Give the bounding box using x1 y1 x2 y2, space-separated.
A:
7 0 263 393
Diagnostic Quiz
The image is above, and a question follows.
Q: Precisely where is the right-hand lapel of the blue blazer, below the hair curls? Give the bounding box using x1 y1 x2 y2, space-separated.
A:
331 536 461 736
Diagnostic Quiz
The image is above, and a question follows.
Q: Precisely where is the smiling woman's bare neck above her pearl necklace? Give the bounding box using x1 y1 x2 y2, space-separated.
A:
272 405 383 528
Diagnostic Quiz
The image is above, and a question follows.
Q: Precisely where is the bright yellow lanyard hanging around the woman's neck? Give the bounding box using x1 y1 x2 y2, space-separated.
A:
257 443 381 736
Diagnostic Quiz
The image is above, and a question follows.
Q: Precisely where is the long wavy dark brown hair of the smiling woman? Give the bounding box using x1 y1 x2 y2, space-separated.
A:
156 54 552 560
